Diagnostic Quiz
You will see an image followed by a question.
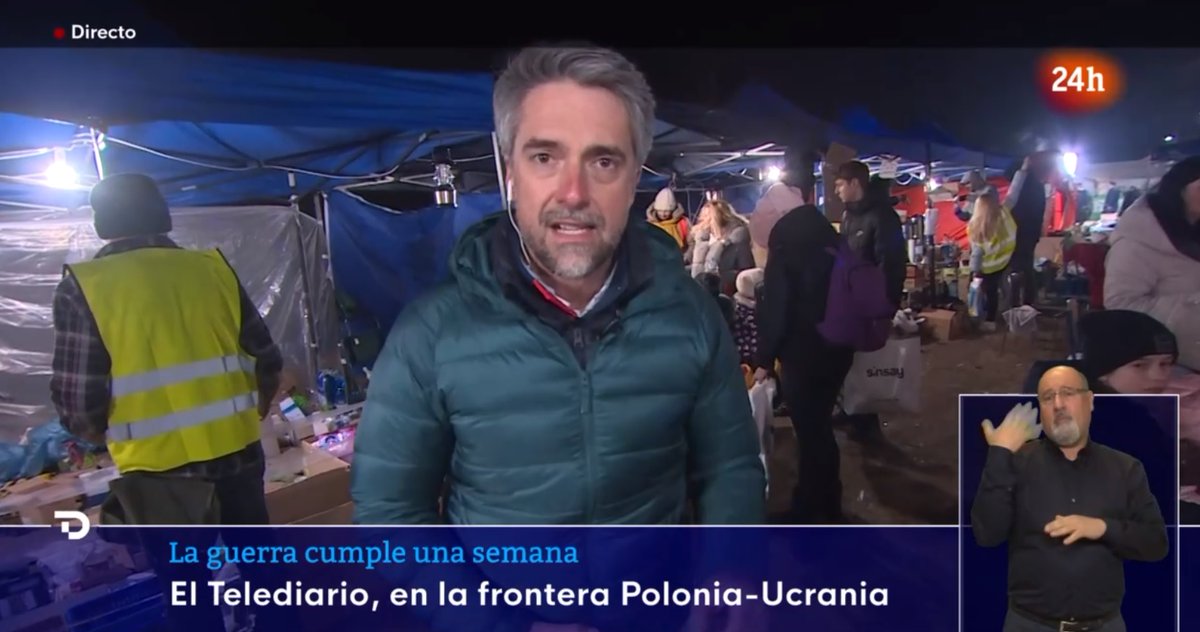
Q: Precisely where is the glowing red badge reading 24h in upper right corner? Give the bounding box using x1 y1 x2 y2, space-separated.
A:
1037 49 1124 114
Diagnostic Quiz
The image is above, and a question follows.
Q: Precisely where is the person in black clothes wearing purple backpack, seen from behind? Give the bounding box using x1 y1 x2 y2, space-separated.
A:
755 171 854 524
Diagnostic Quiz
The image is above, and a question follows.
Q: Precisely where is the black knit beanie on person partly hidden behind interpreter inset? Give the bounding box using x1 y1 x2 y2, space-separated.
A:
1079 309 1180 381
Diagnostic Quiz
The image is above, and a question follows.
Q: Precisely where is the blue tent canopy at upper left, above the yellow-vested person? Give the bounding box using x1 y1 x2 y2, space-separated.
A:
0 49 492 207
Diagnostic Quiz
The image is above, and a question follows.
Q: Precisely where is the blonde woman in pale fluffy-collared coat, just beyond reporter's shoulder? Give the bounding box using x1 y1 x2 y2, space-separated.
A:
684 200 755 294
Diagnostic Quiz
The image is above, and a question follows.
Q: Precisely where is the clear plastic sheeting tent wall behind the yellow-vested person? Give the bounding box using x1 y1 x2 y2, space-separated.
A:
0 206 338 443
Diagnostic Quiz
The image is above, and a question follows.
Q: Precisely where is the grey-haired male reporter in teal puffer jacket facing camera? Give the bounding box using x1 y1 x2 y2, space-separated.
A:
352 48 766 631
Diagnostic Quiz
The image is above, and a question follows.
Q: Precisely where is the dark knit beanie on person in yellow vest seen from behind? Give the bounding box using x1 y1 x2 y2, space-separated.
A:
91 174 172 241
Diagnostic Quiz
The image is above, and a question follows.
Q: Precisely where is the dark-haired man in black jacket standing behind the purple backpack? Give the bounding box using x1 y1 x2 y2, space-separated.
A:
835 161 908 439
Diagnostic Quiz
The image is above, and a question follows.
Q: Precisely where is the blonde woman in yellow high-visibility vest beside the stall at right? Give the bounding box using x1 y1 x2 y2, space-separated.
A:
967 192 1016 331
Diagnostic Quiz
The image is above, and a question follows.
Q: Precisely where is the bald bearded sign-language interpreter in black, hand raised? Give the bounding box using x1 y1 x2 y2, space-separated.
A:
971 366 1168 632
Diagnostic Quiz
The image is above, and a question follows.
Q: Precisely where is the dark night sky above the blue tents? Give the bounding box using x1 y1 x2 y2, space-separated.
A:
16 0 1200 161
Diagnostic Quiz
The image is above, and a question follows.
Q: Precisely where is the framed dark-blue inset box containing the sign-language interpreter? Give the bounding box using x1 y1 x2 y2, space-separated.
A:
959 388 1180 632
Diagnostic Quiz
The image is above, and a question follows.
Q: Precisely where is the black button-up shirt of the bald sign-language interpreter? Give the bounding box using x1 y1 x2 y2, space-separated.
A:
971 439 1168 621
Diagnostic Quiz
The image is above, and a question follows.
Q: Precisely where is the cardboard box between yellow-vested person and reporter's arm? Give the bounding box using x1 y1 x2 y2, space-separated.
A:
264 444 350 524
